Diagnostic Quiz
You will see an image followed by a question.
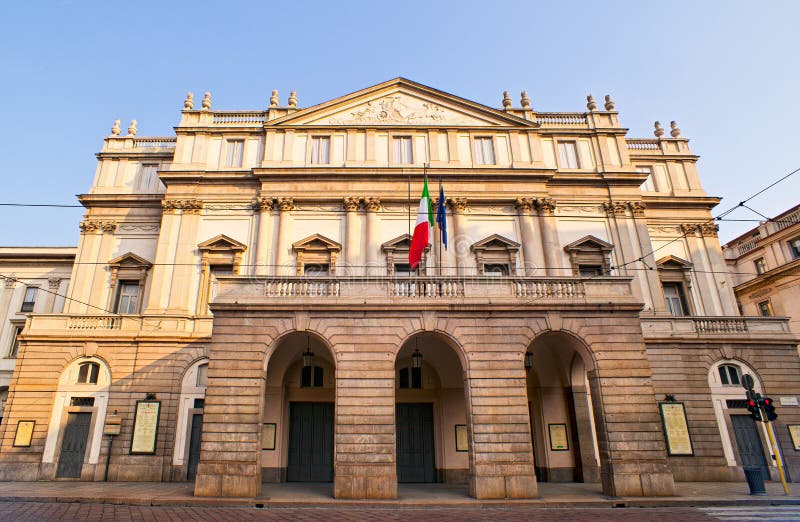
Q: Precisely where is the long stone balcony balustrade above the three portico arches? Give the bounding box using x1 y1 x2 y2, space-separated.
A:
212 276 641 309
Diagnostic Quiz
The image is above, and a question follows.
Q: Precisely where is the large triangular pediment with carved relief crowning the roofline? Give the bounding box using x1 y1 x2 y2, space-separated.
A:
270 78 537 127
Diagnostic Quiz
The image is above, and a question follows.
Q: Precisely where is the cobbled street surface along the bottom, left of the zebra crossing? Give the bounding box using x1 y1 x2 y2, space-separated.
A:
0 502 724 522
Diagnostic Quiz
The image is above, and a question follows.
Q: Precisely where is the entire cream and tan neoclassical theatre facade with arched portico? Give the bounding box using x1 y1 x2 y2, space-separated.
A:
0 78 800 499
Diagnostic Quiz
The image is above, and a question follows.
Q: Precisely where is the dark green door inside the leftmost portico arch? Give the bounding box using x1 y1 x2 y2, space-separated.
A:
286 402 333 482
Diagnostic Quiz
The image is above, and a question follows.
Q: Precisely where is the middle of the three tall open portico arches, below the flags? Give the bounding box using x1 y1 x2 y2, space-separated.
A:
395 332 470 484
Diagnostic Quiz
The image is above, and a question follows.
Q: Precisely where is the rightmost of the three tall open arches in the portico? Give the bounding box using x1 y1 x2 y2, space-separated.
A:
526 332 600 482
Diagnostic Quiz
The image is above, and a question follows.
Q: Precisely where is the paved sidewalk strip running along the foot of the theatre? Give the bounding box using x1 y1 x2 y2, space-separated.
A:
0 481 800 508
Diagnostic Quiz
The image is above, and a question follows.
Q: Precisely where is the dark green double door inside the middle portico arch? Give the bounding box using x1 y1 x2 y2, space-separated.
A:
395 403 436 482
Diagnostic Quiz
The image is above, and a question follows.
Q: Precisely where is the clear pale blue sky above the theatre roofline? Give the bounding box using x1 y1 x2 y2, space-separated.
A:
0 0 800 245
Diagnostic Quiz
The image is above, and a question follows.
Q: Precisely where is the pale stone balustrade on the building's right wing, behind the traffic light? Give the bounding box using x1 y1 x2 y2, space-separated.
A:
642 316 792 340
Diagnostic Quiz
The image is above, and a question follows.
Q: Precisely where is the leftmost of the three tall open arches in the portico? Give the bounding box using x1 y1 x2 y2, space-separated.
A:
261 332 336 482
